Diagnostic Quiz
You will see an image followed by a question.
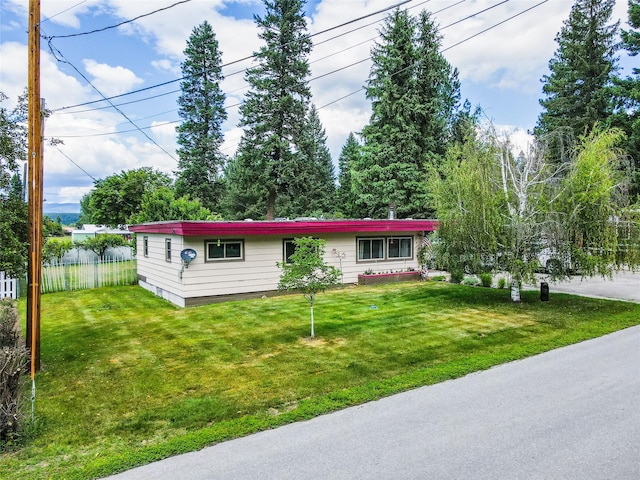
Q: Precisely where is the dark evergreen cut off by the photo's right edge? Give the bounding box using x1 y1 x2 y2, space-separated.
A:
611 0 640 198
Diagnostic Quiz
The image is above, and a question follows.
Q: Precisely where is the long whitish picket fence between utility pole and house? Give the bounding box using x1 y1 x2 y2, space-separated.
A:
41 260 138 293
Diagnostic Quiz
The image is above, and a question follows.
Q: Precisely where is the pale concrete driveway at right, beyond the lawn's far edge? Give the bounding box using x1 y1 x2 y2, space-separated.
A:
531 271 640 303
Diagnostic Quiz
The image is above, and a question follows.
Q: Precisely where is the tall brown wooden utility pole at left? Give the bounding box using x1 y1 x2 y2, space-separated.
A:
27 0 44 374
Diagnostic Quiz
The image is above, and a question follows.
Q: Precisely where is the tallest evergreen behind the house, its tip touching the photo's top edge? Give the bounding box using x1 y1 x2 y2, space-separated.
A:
226 0 312 219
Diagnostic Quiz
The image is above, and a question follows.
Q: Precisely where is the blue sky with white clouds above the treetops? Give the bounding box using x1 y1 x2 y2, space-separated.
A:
0 0 637 211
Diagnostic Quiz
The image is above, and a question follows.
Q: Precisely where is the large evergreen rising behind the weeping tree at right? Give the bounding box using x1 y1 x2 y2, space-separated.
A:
535 0 618 136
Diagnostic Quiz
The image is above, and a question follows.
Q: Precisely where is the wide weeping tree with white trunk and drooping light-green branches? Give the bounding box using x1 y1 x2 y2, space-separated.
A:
431 127 640 301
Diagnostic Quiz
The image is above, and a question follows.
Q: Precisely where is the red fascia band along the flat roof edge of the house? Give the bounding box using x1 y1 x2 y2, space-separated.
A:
129 220 438 237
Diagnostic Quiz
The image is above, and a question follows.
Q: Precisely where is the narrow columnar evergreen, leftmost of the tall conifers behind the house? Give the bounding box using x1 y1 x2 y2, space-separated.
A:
176 20 227 211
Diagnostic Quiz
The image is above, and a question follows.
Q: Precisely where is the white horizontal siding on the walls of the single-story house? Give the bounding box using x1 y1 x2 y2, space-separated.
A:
138 232 420 306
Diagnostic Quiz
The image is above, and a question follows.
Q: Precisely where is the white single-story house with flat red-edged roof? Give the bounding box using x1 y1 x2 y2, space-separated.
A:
129 219 437 307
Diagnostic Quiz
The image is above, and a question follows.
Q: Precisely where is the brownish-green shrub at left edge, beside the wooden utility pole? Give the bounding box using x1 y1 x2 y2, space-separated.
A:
0 300 27 442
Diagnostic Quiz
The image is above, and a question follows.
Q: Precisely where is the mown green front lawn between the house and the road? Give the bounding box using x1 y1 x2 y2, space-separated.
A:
0 282 640 479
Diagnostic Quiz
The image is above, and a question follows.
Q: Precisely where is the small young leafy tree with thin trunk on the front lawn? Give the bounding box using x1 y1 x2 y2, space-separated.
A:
276 237 341 337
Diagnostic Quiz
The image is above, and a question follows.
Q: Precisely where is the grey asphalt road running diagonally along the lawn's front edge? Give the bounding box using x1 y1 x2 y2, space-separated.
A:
106 326 640 480
